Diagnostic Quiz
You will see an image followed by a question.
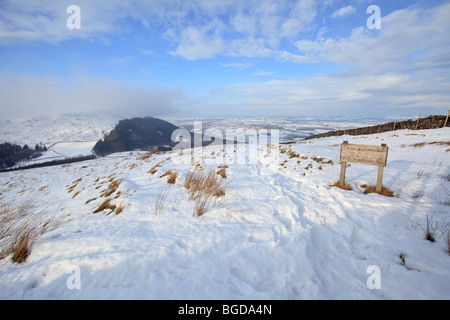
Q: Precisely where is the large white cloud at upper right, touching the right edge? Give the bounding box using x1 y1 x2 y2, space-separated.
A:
297 4 450 74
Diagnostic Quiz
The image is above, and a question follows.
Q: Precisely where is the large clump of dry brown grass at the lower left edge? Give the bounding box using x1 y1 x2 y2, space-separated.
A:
0 199 64 263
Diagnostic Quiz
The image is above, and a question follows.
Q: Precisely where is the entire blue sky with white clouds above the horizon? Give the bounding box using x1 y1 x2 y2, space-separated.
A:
0 0 450 118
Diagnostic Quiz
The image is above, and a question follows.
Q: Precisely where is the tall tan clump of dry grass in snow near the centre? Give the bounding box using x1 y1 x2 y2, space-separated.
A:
184 170 229 216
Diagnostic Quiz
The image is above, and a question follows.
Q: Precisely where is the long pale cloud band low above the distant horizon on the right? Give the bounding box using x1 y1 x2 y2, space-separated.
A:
202 70 450 116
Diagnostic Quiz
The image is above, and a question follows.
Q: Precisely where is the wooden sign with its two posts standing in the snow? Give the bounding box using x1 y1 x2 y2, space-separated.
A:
339 141 389 193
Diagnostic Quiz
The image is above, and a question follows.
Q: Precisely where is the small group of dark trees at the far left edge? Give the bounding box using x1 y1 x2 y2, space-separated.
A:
0 142 47 169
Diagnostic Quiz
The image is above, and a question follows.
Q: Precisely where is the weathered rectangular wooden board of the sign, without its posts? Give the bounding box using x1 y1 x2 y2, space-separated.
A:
341 141 389 167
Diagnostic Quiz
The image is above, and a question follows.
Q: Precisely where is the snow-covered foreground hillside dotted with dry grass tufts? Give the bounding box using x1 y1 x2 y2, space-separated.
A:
0 128 450 299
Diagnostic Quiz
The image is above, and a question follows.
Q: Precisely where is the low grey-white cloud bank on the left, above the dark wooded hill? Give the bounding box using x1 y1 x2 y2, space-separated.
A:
0 72 190 118
